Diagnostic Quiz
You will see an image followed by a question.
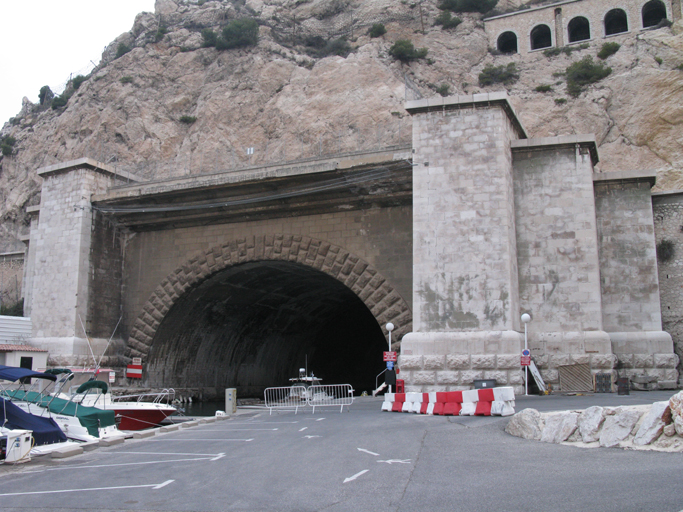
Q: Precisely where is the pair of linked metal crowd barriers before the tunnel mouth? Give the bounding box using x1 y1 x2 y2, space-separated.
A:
264 384 353 414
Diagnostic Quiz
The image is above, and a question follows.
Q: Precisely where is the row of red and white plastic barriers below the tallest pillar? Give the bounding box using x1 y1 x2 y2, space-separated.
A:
382 386 515 416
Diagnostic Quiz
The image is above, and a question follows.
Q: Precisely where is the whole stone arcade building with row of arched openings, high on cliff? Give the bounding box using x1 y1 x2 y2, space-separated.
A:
484 0 681 54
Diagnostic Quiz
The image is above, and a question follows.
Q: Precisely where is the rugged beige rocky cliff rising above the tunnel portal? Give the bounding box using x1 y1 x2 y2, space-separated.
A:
0 0 683 252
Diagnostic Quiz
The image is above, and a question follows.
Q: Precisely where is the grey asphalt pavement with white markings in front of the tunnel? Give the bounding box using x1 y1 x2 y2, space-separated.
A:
0 392 683 512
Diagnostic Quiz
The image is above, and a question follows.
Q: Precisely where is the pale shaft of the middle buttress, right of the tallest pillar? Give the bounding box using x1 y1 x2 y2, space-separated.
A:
514 146 602 334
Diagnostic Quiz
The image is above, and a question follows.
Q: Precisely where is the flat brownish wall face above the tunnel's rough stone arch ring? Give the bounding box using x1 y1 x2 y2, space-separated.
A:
123 206 412 341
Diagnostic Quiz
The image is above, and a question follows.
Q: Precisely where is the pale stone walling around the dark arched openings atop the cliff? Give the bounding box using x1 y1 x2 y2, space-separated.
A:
485 0 680 54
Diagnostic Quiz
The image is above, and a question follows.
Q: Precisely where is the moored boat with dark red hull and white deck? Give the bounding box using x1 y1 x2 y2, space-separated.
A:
54 369 178 431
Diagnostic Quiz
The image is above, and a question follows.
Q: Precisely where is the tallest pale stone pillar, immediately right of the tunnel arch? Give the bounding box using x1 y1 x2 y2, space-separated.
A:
400 93 526 391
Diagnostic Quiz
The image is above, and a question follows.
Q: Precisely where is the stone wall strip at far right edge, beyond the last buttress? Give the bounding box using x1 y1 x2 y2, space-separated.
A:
652 192 683 382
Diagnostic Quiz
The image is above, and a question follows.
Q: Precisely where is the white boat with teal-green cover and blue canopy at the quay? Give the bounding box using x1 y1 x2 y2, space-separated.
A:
0 365 124 441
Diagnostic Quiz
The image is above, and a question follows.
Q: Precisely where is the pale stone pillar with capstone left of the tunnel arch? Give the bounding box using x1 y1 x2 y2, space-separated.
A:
27 158 138 364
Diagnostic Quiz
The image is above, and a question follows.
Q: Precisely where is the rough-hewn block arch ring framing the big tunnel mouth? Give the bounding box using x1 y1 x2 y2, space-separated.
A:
128 234 412 357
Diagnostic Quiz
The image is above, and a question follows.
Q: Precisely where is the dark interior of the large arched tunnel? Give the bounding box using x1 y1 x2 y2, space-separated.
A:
147 261 387 399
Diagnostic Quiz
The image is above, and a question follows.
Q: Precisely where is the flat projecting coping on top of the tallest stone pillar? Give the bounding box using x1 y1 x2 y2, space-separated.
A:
405 91 528 139
